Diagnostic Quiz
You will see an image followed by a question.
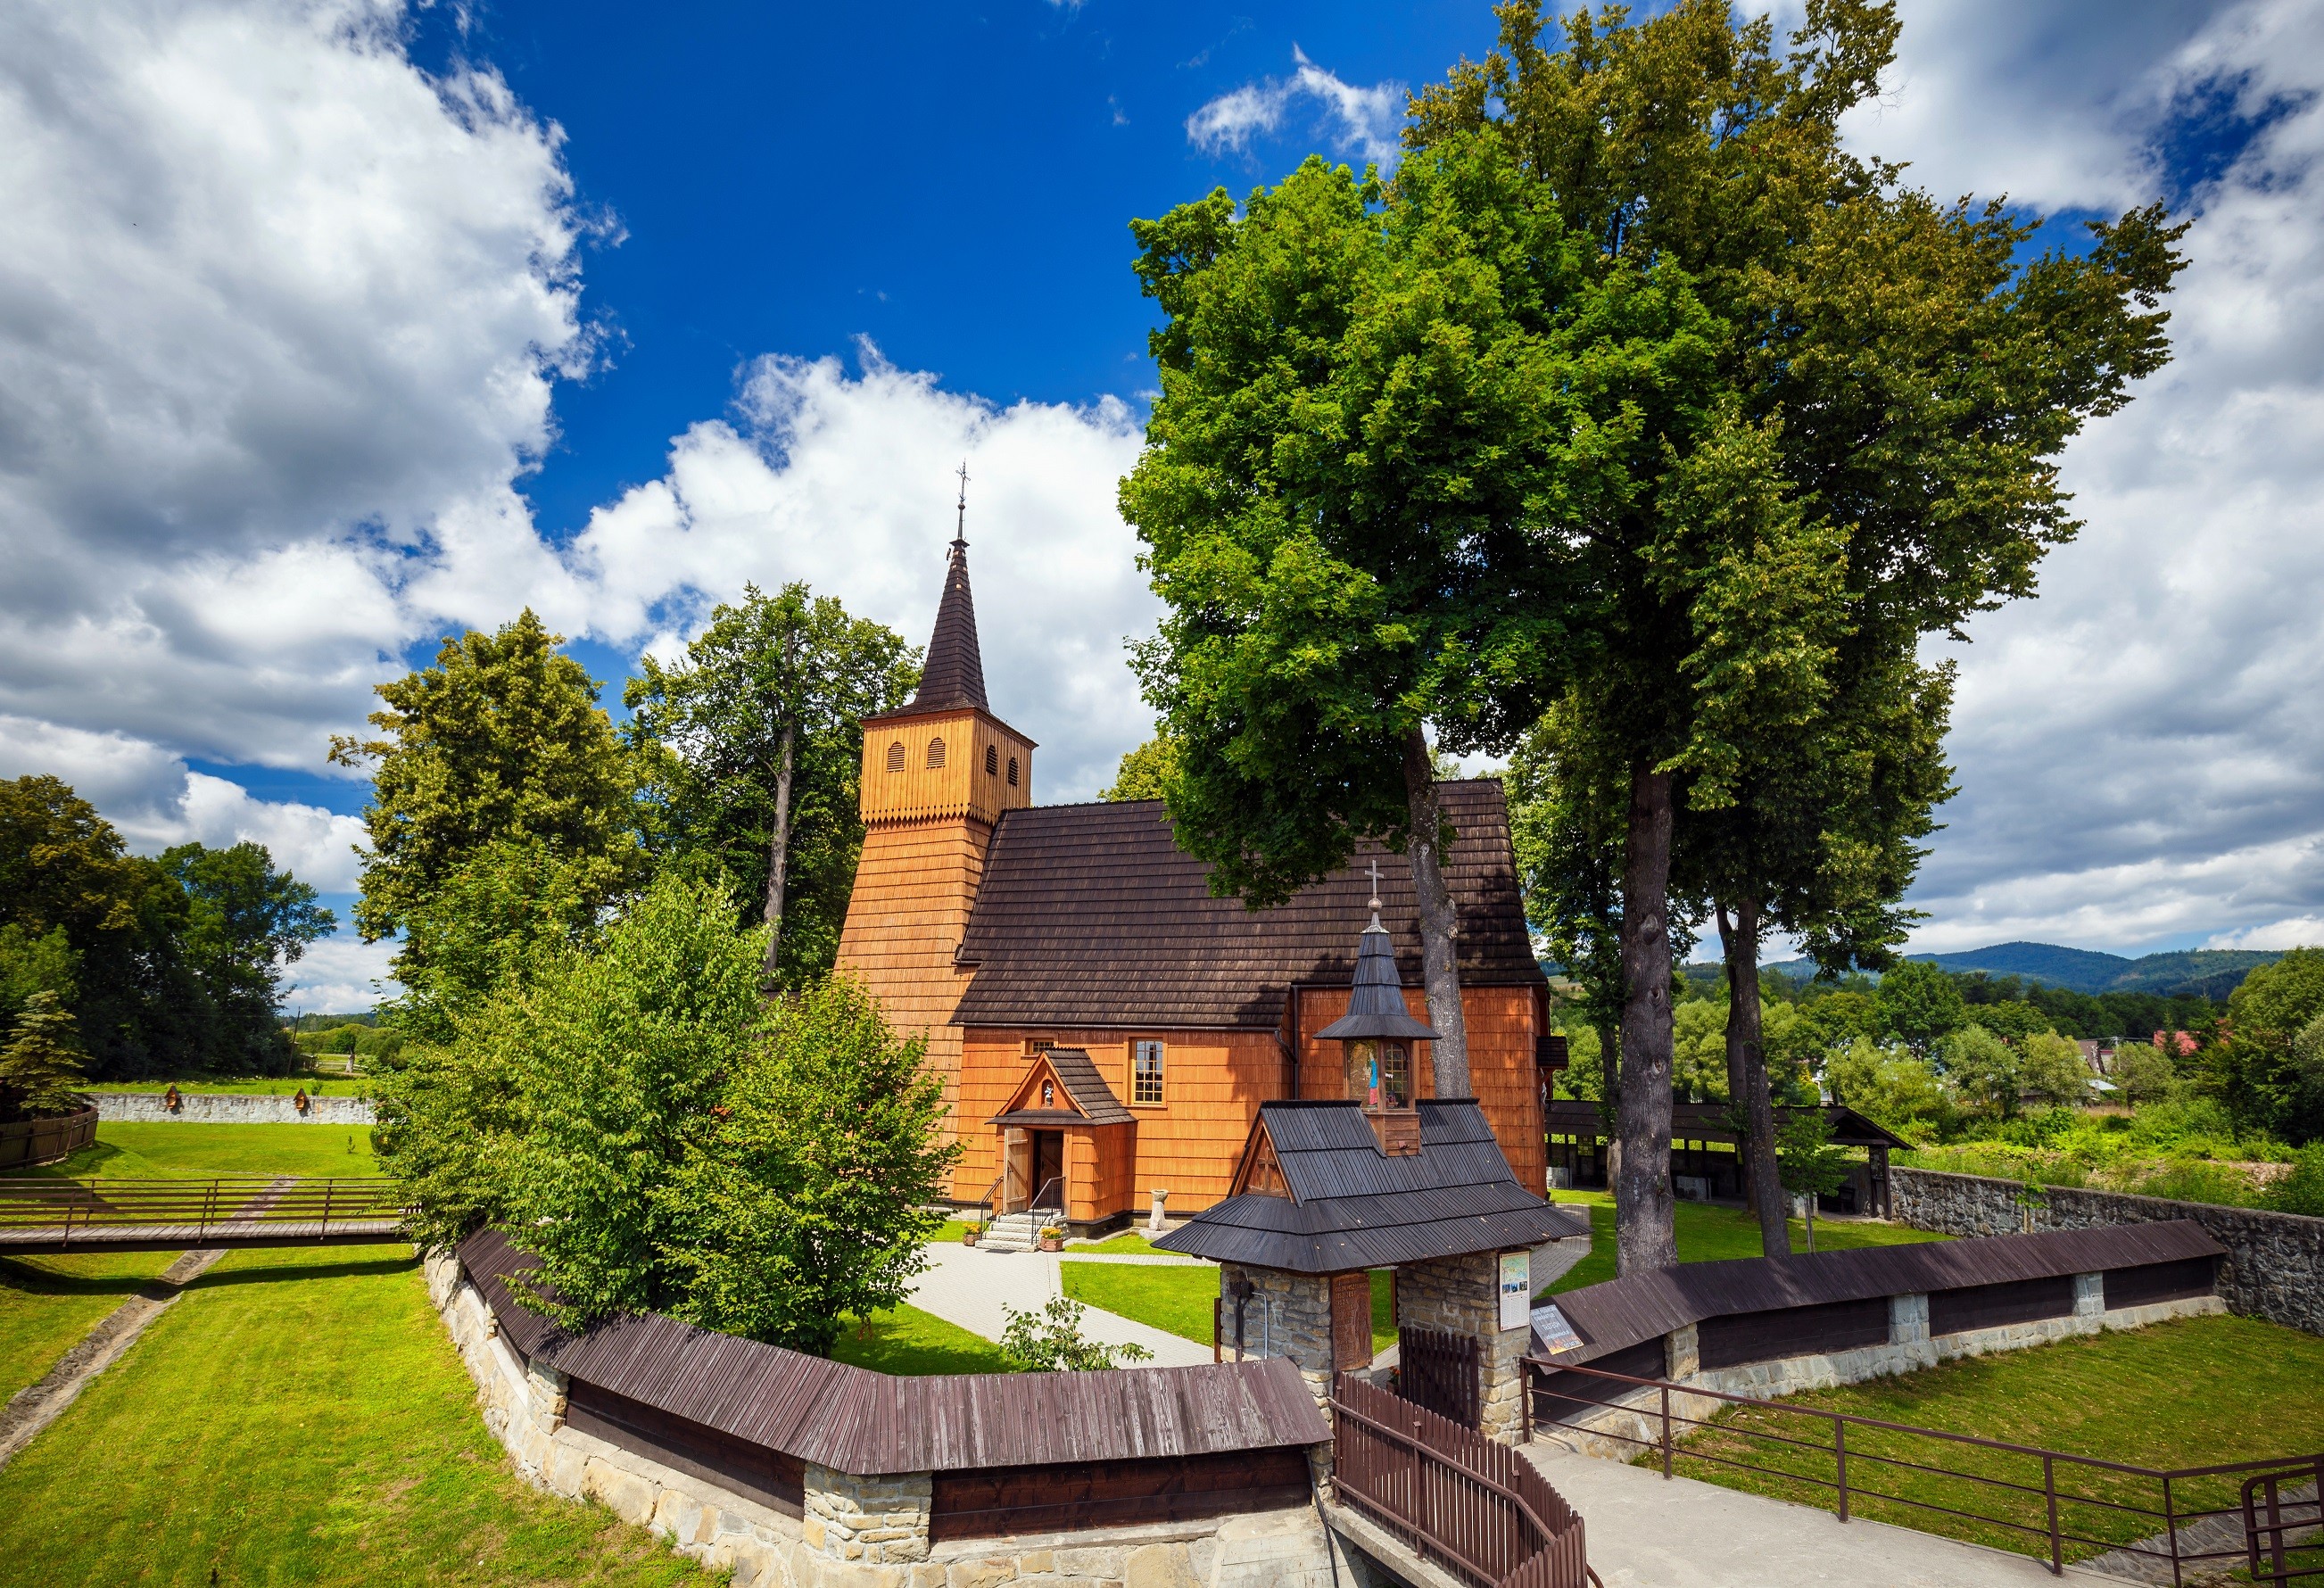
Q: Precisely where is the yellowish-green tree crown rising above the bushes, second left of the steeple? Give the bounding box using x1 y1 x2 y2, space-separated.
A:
330 609 641 986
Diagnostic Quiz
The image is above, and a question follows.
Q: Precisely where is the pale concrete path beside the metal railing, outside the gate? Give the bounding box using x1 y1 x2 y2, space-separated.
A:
1525 1439 2121 1588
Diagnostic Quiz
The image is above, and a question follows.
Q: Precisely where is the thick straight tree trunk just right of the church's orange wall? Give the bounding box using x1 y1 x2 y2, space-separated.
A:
1613 767 1678 1274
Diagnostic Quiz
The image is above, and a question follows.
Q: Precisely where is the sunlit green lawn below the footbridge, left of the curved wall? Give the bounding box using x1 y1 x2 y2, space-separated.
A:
0 1245 723 1588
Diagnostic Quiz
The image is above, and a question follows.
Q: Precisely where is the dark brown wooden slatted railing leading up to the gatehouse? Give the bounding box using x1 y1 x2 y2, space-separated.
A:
1332 1374 1597 1588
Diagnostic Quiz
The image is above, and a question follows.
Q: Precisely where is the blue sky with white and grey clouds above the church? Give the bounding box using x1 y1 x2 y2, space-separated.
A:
0 0 2324 1006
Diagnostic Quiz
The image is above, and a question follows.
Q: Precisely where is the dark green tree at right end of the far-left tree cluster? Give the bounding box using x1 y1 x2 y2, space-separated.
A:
161 841 339 1074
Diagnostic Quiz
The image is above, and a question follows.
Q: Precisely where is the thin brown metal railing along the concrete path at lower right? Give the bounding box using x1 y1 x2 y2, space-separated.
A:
1526 1358 2324 1584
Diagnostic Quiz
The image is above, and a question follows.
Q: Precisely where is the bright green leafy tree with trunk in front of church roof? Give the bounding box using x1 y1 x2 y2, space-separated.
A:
1121 139 1617 1095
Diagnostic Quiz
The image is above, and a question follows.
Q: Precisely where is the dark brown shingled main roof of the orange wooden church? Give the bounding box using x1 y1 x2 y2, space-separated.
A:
953 779 1543 1030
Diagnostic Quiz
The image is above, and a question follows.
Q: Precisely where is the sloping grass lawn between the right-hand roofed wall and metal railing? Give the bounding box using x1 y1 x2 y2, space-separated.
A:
1645 1319 2324 1560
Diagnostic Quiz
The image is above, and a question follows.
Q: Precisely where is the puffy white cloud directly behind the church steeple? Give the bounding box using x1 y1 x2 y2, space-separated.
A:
572 344 1157 800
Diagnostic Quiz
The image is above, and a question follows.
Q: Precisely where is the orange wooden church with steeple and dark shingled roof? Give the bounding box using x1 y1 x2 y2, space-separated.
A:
839 527 1548 1232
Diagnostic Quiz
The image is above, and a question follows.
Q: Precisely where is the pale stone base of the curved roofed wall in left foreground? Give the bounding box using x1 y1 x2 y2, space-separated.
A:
427 1255 1347 1588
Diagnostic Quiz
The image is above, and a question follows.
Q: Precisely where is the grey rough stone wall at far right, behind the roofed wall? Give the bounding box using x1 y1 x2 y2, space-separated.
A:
1890 1170 2324 1335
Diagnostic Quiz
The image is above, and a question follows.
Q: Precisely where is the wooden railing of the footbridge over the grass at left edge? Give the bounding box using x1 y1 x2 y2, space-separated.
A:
0 1174 404 1251
